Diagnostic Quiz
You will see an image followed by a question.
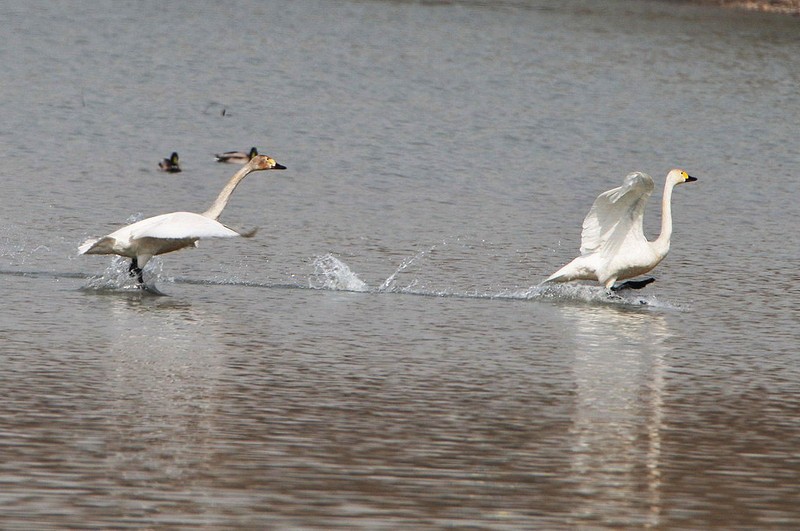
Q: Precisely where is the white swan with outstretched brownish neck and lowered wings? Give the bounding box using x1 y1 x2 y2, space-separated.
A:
78 155 286 285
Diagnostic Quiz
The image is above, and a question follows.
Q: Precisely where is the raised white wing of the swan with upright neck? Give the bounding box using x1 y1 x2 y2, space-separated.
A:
581 172 653 255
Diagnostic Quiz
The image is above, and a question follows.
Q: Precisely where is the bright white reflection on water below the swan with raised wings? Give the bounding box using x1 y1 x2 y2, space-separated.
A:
561 306 671 526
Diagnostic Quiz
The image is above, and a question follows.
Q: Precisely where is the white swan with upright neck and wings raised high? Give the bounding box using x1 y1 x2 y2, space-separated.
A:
545 170 697 290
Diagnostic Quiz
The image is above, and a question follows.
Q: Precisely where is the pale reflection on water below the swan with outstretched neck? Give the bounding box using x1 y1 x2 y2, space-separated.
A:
97 296 225 525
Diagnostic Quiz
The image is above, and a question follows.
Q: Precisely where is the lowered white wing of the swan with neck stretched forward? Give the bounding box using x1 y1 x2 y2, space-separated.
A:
119 212 240 241
